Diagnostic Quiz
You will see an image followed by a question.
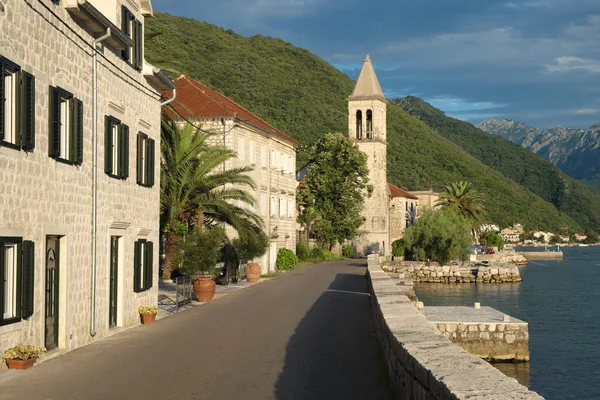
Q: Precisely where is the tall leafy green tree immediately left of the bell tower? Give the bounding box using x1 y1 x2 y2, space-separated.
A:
297 133 372 250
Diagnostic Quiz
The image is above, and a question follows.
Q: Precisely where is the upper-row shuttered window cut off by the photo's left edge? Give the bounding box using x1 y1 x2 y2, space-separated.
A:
0 57 35 151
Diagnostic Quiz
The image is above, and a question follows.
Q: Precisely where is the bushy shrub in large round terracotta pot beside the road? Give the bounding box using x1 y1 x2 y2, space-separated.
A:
175 227 226 302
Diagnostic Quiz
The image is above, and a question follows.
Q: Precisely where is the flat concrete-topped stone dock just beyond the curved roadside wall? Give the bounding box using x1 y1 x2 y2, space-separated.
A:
424 303 529 362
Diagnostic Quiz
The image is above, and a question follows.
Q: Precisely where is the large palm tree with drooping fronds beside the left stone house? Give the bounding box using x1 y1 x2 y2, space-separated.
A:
160 118 263 277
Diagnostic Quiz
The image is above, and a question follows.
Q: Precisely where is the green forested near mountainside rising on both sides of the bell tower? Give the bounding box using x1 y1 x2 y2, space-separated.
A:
145 13 600 231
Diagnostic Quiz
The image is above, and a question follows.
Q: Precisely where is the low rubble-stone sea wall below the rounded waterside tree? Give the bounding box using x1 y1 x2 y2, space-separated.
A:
383 261 521 283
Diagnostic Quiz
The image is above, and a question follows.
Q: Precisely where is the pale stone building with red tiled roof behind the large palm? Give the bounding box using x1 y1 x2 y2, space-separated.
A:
172 75 299 273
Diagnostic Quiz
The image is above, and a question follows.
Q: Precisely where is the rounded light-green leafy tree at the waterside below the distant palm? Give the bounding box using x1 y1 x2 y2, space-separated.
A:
404 208 473 264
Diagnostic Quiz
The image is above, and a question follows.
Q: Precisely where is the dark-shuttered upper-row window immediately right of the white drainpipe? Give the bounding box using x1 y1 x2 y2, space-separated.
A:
104 115 129 179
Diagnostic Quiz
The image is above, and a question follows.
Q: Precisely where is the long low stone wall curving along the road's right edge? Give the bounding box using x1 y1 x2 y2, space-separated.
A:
368 260 543 400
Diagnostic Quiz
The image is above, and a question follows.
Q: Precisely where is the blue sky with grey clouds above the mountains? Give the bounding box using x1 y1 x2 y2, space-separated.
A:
152 0 600 128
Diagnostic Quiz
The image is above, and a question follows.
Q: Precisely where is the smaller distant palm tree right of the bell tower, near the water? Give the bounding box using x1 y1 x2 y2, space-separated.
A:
436 181 484 237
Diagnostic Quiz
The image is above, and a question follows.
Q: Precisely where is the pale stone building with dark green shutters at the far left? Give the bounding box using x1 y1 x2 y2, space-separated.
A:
0 0 174 355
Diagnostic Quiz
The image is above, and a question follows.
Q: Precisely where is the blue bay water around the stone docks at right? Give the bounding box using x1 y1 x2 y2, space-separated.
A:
415 246 600 400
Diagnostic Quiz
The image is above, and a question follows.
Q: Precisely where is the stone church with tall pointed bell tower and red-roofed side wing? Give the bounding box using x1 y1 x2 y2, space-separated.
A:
348 56 439 256
